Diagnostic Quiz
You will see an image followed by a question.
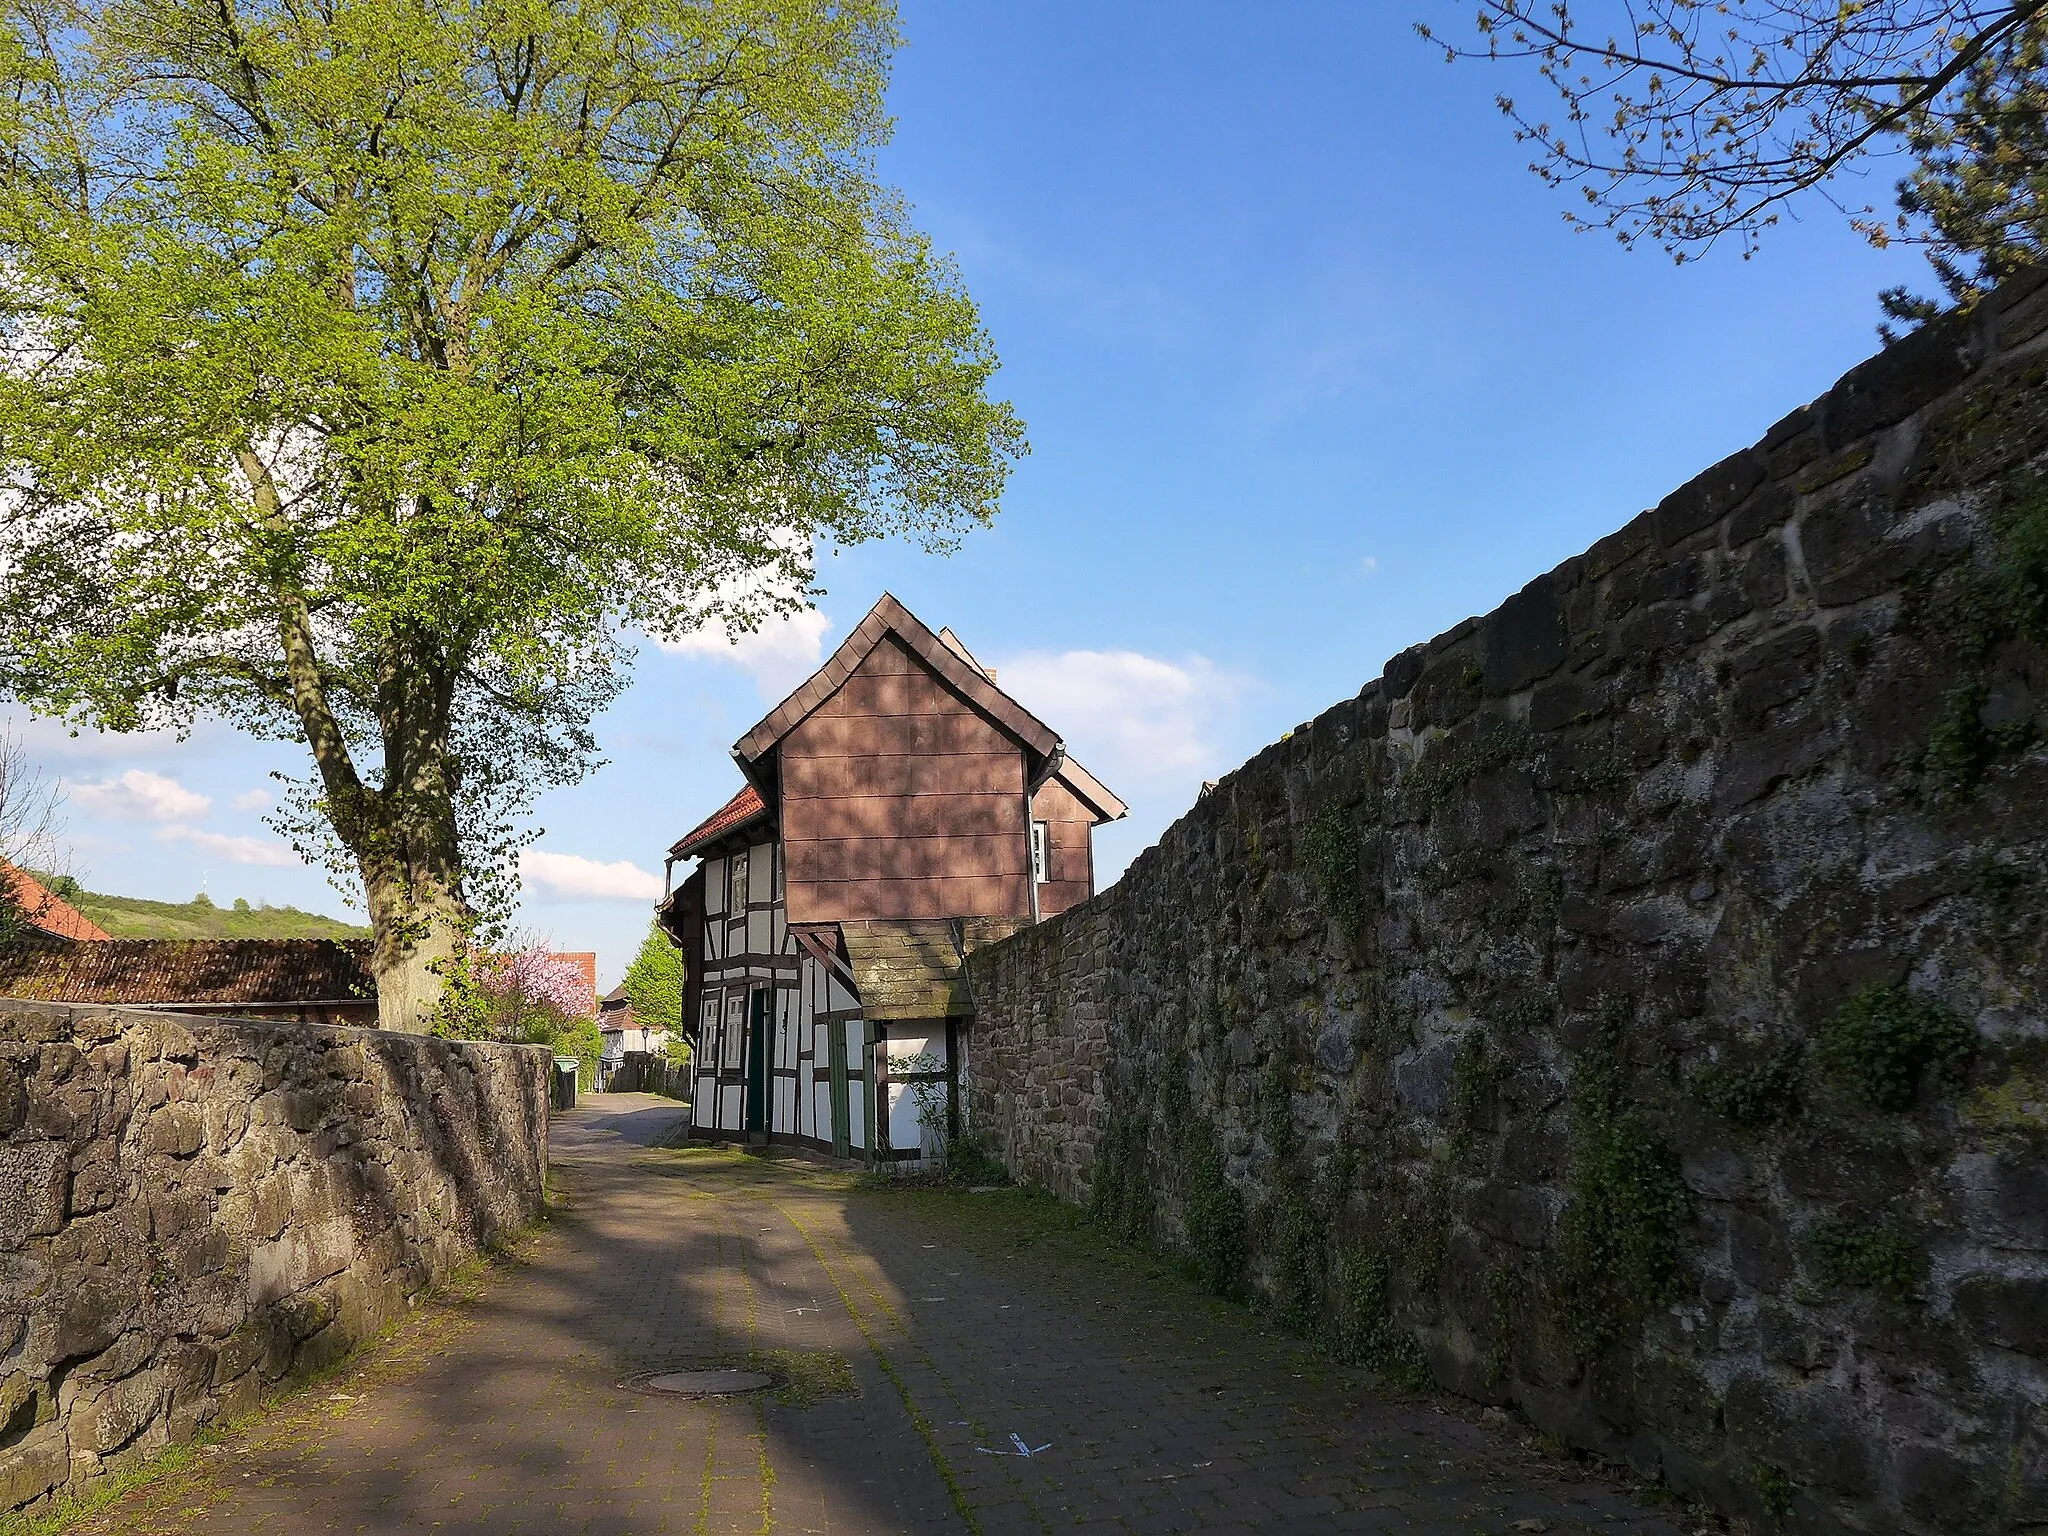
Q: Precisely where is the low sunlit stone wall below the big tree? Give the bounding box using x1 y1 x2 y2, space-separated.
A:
0 999 549 1516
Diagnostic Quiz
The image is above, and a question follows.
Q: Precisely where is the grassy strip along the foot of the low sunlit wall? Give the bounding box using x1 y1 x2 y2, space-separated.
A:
0 1219 549 1536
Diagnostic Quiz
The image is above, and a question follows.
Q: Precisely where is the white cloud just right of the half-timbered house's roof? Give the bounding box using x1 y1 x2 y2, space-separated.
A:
997 651 1245 791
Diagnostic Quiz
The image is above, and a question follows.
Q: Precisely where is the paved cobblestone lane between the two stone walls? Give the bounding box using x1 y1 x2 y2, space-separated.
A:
90 1094 1683 1536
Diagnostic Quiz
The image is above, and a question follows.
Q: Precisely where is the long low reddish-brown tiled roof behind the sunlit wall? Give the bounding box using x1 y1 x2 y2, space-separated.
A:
0 938 377 1006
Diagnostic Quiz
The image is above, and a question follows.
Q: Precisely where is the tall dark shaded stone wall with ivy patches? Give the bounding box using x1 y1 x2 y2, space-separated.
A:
969 281 2048 1532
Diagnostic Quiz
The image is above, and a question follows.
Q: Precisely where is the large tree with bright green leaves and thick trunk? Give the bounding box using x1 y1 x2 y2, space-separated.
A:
0 0 1024 1028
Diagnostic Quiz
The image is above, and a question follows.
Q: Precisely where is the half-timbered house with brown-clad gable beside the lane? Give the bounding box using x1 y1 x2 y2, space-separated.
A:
657 596 1124 1161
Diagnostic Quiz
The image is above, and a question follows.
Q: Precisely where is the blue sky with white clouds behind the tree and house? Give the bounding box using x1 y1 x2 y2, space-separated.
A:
14 0 1927 985
